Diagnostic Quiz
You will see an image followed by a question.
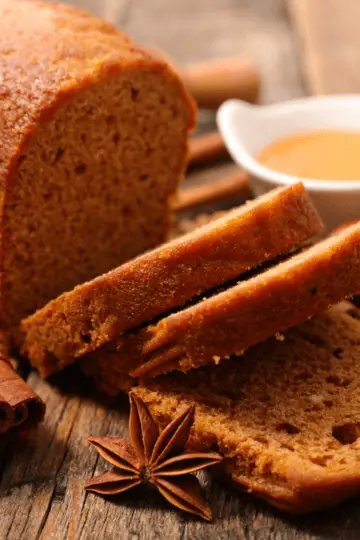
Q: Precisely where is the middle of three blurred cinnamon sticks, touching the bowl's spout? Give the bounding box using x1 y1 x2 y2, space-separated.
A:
188 131 229 168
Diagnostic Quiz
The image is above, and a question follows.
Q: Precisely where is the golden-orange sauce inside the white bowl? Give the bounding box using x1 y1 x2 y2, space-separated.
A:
258 131 360 180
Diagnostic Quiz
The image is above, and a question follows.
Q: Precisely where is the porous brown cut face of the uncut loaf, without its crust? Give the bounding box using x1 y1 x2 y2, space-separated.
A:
1 69 189 331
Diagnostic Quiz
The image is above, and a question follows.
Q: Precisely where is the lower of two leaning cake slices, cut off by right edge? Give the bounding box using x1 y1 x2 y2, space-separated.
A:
82 219 360 388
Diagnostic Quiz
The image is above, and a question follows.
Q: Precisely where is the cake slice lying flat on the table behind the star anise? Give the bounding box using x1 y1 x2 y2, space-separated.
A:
133 304 360 513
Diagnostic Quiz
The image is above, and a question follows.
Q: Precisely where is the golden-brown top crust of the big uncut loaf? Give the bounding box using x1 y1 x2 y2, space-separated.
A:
0 0 195 332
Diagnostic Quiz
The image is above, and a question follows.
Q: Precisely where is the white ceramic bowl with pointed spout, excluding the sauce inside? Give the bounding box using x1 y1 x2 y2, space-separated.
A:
217 94 360 230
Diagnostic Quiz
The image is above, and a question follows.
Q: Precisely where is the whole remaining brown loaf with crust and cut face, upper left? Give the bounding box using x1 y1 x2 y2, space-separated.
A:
0 0 194 329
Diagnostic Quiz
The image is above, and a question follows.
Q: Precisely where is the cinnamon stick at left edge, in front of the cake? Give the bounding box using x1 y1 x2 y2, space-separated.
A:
0 354 45 433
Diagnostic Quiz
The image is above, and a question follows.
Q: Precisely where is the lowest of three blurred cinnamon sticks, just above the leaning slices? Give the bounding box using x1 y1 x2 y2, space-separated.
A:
173 172 251 212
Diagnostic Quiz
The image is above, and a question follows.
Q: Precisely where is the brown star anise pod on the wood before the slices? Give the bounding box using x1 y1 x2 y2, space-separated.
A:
85 394 222 520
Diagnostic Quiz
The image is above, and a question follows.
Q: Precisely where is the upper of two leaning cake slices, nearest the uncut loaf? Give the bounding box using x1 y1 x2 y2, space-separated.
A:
22 183 322 376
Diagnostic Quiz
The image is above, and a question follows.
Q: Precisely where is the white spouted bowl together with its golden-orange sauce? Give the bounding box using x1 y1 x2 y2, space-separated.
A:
217 94 360 229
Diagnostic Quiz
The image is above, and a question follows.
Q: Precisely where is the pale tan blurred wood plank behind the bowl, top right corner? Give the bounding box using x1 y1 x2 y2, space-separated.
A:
287 0 360 94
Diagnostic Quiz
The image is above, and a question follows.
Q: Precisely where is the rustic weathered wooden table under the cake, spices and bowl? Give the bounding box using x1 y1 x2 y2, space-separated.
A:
0 0 360 540
